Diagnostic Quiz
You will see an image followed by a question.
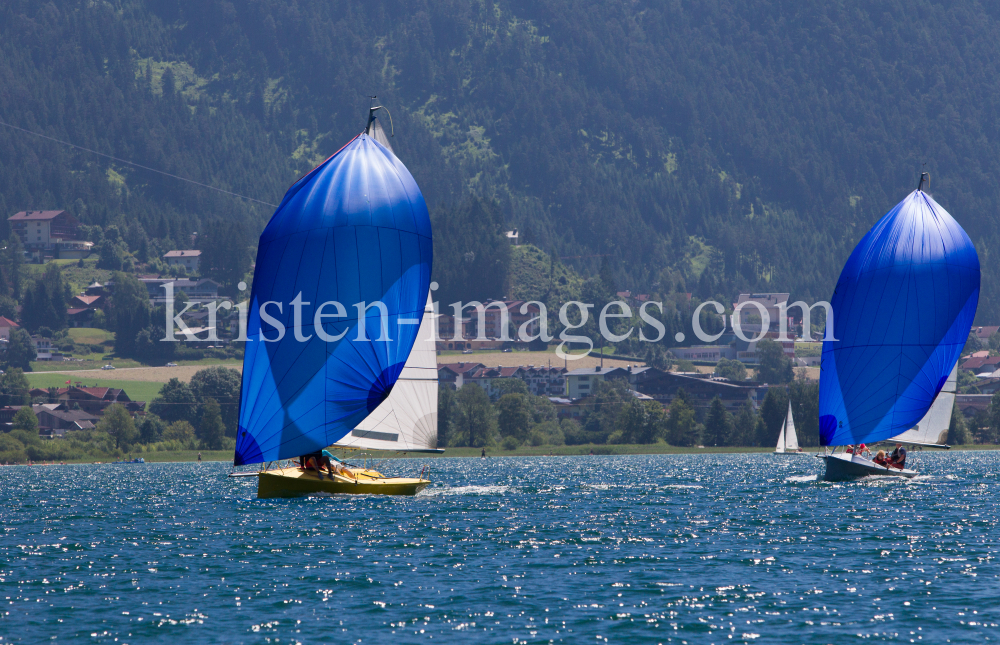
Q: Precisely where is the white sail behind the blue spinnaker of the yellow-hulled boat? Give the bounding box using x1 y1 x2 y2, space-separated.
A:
334 294 438 452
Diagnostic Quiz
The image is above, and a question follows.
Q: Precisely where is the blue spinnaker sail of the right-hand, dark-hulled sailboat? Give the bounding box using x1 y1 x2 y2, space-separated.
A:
819 190 979 446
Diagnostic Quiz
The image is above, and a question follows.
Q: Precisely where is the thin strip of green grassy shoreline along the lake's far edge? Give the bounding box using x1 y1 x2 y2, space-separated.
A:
9 444 1000 466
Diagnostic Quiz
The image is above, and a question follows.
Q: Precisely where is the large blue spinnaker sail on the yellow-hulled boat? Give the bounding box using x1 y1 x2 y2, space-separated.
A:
240 134 432 465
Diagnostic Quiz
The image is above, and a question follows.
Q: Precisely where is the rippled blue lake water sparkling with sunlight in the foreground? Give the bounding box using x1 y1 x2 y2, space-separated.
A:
0 452 1000 644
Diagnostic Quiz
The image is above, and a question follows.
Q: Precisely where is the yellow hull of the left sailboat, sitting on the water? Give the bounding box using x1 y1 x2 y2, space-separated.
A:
257 468 431 497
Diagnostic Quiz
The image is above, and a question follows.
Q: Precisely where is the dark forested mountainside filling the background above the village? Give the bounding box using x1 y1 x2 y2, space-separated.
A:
0 0 1000 321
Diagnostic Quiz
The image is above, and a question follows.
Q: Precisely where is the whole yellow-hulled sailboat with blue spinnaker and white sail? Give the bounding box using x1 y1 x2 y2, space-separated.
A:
233 103 441 497
